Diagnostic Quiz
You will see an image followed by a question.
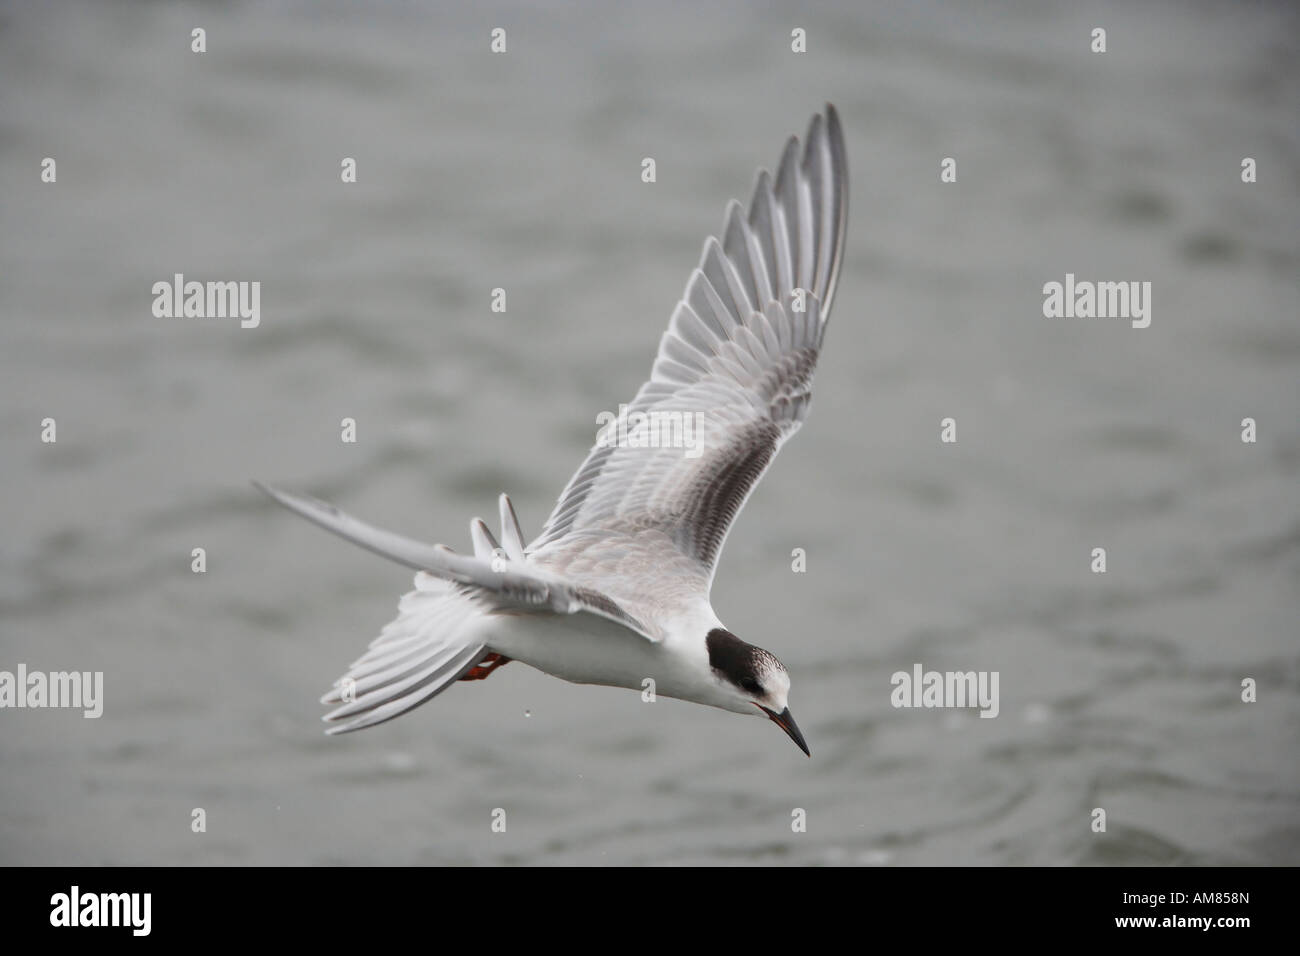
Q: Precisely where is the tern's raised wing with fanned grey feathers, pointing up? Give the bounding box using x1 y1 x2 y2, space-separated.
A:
528 105 848 609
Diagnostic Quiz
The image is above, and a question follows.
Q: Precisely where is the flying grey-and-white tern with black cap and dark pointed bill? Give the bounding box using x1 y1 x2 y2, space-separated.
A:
255 104 848 756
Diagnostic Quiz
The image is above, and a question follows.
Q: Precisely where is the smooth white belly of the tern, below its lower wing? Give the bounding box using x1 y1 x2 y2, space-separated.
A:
486 614 681 696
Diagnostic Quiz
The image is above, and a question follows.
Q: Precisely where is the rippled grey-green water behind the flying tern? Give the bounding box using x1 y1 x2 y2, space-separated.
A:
0 3 1300 864
